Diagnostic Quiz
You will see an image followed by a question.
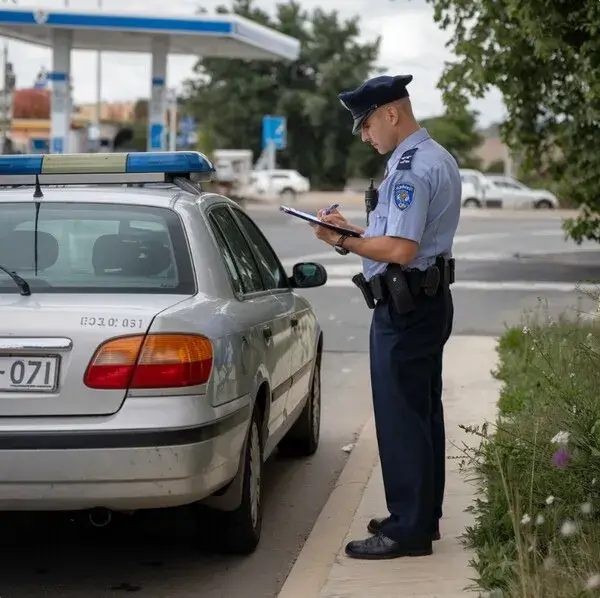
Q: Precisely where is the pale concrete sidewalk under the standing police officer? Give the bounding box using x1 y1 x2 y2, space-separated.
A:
279 336 499 598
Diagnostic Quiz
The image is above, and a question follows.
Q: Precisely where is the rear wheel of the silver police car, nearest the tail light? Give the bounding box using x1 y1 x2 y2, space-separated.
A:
217 408 263 554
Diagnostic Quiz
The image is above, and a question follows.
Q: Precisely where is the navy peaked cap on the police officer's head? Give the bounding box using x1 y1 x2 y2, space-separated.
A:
338 75 412 134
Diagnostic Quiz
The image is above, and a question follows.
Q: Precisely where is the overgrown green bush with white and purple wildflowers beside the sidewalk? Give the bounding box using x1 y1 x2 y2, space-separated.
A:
463 312 600 598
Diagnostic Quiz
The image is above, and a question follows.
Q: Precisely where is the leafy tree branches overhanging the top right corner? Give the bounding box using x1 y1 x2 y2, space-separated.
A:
427 0 600 242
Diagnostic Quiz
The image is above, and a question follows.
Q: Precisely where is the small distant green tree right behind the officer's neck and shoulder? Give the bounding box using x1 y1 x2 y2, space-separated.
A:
421 110 483 169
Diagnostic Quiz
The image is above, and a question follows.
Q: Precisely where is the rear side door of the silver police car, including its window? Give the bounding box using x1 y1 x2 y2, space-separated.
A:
208 205 291 435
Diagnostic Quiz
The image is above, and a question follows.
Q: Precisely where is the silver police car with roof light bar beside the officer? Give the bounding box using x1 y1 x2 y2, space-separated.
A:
0 152 327 553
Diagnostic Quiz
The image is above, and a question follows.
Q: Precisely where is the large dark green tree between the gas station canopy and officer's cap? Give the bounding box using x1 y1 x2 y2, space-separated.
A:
185 0 380 188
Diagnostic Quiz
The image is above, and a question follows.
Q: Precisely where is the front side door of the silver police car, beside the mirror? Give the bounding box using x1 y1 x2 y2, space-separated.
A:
233 208 315 424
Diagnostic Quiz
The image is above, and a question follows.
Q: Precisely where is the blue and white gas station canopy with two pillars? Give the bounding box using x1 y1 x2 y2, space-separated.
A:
0 5 300 154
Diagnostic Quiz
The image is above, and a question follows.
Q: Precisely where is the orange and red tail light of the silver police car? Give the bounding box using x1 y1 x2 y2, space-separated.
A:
84 334 213 390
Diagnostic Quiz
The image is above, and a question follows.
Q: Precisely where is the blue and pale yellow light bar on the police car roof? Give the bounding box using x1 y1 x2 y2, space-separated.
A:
0 152 215 176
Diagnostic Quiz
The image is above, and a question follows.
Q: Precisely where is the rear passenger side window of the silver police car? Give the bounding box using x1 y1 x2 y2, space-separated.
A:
210 208 265 293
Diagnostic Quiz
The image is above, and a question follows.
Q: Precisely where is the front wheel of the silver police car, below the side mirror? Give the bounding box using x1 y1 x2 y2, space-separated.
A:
278 353 321 457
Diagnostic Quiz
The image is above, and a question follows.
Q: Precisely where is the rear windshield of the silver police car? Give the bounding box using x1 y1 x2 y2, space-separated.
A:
0 201 195 295
